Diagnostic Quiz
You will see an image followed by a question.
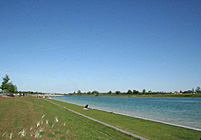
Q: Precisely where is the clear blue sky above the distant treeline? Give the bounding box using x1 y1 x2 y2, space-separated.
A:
0 0 201 93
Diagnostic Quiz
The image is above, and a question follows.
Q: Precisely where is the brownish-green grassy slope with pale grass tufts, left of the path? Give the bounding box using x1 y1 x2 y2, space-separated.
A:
0 97 138 140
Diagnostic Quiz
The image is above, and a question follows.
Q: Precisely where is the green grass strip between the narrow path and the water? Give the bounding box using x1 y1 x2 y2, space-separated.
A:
52 100 201 140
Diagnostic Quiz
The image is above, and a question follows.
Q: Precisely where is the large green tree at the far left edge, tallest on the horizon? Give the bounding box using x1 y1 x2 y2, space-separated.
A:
0 74 17 93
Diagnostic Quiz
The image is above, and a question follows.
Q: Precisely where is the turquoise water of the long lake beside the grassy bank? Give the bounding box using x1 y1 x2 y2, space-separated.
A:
55 96 201 129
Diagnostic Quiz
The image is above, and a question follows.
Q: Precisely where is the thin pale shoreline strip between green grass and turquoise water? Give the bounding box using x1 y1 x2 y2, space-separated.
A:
52 98 201 131
